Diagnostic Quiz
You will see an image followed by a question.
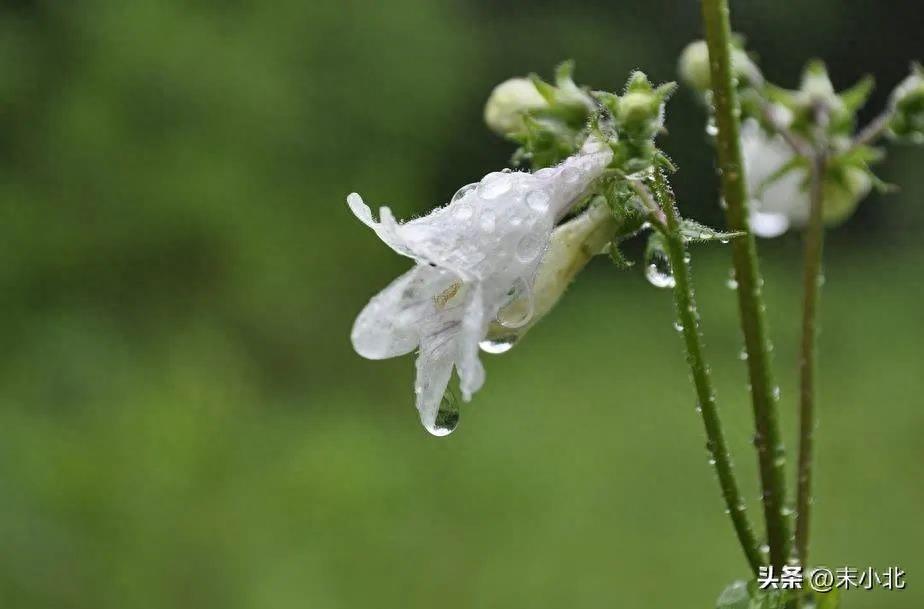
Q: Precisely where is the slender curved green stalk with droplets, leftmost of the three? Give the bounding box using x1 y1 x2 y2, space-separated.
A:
655 171 765 574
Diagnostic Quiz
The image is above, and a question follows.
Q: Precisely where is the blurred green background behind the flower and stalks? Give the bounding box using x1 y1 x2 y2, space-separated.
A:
0 0 924 609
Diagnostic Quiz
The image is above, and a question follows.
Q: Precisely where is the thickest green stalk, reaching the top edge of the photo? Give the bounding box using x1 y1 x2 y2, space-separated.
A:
702 0 791 567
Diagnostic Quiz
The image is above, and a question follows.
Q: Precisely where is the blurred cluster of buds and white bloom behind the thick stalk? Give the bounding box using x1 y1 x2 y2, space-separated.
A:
679 39 924 237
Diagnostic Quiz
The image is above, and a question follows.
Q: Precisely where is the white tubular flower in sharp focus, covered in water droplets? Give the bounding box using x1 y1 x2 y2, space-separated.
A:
347 142 612 435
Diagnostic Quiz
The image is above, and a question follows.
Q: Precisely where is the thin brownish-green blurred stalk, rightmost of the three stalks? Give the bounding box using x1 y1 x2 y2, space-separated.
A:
796 154 825 564
